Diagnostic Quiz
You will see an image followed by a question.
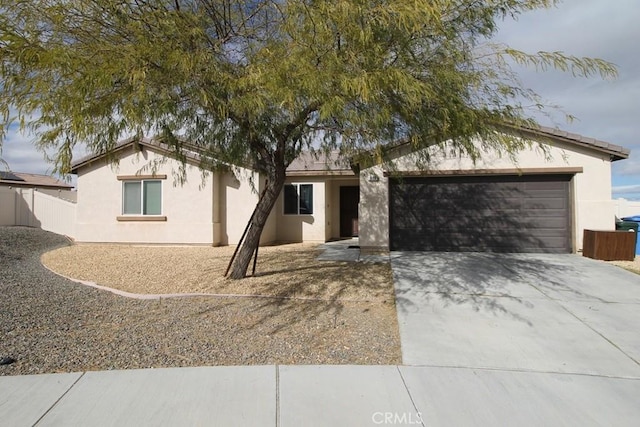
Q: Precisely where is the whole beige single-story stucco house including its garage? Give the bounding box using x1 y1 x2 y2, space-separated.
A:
72 127 629 253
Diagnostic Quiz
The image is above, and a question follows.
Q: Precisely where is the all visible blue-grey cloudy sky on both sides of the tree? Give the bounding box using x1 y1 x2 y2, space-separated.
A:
0 0 640 200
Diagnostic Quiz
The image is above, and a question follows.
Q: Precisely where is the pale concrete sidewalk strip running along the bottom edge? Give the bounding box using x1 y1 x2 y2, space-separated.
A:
0 366 640 427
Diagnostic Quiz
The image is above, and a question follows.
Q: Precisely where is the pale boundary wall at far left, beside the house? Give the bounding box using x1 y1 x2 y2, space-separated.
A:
0 187 76 238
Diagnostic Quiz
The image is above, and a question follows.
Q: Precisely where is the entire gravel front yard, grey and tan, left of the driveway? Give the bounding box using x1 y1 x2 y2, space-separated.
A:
0 227 401 375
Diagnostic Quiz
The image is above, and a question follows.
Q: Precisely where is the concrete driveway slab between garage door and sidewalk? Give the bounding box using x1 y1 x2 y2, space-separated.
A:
391 252 640 376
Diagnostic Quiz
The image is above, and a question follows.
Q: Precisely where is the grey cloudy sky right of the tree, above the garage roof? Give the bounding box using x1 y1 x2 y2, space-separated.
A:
497 0 640 147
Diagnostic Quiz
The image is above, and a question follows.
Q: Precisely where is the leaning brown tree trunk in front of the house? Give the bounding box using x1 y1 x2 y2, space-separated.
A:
229 170 285 279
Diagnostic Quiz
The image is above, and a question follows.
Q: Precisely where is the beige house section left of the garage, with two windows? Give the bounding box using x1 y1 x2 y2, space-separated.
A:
72 138 359 245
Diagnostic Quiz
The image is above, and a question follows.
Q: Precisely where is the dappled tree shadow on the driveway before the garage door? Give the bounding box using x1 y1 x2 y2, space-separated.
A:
391 252 602 325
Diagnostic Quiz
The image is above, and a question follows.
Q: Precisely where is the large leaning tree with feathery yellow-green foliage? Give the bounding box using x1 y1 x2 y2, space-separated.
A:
0 0 615 278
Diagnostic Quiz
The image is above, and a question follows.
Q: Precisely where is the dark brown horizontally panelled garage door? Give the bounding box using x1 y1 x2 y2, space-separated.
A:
389 175 571 253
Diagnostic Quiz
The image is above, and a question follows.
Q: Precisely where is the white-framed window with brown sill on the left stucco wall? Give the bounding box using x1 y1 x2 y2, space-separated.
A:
122 180 162 215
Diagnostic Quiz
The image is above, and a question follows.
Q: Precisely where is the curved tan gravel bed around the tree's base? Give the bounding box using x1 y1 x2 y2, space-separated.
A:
42 244 393 302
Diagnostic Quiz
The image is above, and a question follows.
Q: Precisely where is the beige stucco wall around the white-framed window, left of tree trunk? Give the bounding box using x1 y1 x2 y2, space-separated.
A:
76 148 257 245
